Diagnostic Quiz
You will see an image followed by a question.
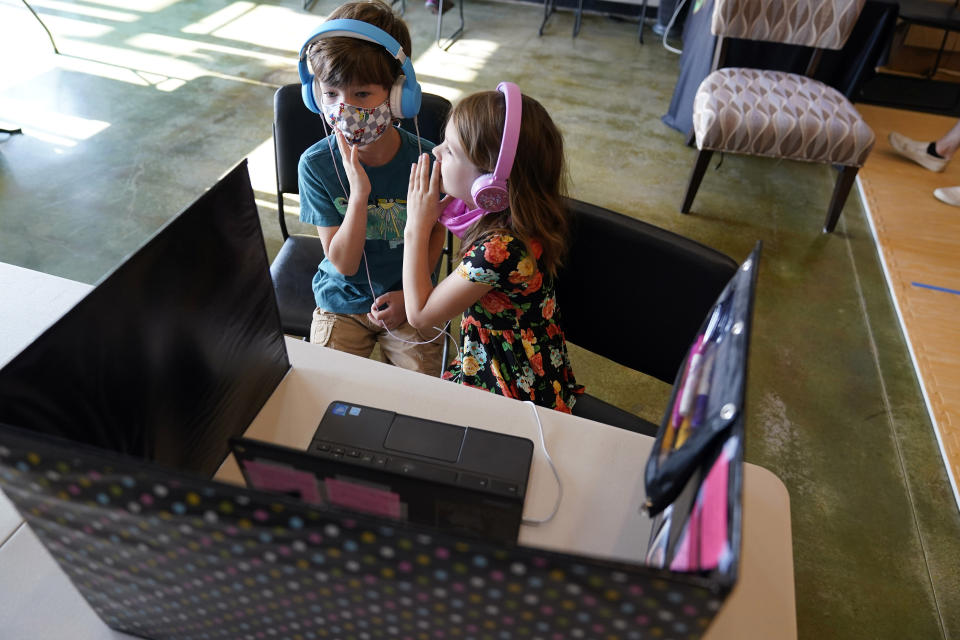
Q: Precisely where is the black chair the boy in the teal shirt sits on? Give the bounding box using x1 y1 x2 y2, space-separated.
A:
270 84 452 338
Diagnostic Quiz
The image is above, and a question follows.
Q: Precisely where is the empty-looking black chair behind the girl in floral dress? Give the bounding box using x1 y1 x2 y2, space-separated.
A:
557 200 738 436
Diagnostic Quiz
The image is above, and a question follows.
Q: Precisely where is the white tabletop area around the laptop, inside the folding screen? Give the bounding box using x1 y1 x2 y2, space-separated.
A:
217 340 653 562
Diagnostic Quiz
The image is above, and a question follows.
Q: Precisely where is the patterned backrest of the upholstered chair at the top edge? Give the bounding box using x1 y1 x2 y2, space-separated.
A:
711 0 866 49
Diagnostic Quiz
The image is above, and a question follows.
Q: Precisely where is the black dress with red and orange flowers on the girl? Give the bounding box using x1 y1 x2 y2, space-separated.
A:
443 234 583 413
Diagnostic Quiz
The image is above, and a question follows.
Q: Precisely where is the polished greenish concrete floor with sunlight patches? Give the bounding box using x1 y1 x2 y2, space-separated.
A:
0 0 960 640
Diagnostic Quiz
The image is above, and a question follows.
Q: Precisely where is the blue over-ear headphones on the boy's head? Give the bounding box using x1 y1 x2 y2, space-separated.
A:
297 18 421 119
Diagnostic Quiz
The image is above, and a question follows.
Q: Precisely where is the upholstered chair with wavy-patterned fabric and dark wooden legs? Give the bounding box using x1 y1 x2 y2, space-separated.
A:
680 0 874 233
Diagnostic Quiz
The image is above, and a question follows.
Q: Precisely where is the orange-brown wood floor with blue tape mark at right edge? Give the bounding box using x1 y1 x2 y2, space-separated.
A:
857 104 960 507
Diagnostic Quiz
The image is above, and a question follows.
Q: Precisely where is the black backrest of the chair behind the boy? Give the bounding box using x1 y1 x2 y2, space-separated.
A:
273 84 452 239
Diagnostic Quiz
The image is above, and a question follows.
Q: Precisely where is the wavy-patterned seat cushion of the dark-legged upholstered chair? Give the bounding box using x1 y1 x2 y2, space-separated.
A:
693 68 874 167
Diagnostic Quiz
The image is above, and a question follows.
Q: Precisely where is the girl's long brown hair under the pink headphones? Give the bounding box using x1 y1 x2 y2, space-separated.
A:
450 91 569 276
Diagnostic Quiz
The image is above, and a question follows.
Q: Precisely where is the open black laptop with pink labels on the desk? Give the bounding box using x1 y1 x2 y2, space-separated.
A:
230 400 533 542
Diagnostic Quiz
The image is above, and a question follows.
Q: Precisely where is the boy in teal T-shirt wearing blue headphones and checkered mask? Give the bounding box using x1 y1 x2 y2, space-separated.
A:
299 0 444 375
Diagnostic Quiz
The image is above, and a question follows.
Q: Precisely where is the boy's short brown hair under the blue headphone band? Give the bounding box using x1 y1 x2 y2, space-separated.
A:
307 0 412 90
